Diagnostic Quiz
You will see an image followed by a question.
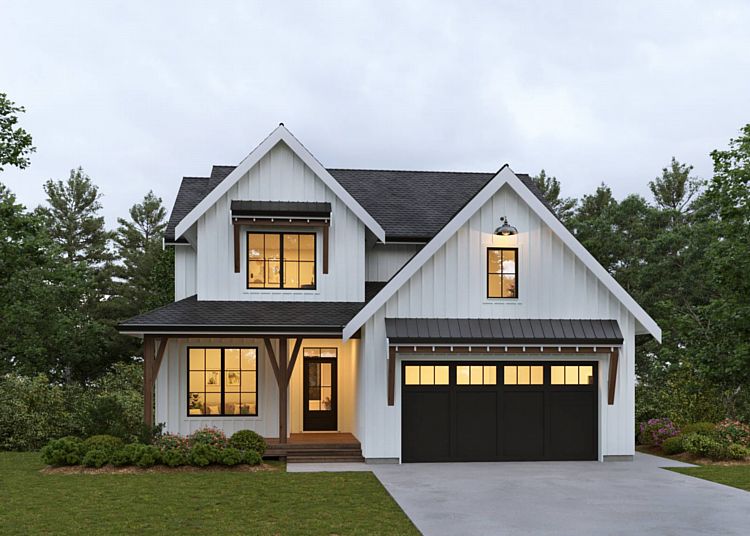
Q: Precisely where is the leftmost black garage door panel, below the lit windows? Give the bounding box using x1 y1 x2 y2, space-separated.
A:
402 390 451 462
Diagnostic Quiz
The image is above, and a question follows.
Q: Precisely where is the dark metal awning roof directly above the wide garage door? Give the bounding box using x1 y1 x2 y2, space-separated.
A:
385 318 622 345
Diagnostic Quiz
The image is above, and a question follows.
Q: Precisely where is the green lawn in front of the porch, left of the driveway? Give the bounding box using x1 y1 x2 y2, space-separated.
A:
0 452 419 536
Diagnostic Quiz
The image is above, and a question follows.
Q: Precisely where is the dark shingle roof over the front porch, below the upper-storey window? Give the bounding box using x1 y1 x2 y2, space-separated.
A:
118 281 385 333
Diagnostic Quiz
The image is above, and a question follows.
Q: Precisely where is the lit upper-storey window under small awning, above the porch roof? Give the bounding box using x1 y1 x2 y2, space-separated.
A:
247 232 315 290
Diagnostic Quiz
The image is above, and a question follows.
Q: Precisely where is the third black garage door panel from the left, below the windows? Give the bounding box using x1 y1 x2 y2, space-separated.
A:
500 391 545 460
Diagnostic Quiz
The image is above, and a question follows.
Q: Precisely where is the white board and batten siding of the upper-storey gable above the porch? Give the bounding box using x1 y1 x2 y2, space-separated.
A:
196 142 365 301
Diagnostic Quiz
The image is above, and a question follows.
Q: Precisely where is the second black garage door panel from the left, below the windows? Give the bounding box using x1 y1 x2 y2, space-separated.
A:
455 390 498 461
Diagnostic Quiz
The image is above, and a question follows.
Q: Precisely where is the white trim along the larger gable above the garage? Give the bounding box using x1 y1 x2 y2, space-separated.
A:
343 169 661 342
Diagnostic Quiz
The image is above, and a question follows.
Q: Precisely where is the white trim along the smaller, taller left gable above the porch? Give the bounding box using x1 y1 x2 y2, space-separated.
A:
175 124 385 242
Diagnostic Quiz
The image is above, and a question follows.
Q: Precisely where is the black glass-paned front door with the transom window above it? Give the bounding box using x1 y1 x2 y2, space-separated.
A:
303 348 338 431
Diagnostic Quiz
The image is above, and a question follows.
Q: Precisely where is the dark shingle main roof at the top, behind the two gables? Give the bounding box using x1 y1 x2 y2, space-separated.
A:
166 166 554 243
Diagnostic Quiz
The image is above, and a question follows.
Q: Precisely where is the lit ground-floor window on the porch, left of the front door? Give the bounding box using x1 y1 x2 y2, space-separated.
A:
188 348 258 416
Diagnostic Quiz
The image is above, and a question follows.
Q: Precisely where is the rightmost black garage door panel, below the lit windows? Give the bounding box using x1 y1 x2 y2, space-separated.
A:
549 391 597 460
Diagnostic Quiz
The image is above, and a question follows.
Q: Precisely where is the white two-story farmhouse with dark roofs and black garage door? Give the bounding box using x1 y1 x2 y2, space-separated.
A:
120 125 661 462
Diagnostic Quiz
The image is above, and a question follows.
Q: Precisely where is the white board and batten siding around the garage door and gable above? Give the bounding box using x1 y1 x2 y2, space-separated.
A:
357 185 636 458
